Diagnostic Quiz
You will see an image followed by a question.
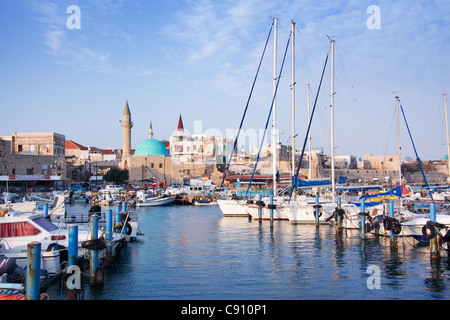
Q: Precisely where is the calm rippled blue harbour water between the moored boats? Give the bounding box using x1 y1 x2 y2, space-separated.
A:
47 205 450 300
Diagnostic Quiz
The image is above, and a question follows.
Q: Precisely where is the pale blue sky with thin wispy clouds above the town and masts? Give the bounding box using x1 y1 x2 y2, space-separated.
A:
0 0 450 159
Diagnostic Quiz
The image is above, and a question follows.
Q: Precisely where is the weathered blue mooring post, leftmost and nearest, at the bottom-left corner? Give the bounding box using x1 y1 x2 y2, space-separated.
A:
25 242 41 300
